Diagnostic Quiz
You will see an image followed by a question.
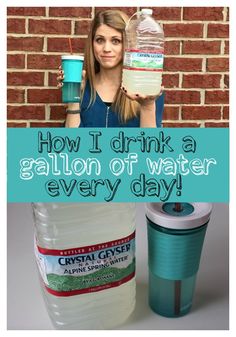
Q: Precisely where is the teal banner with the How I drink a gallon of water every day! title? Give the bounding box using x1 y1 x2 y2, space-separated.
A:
7 128 229 202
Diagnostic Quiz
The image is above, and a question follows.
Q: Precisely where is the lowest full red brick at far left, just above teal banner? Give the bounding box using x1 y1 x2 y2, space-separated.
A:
7 105 45 119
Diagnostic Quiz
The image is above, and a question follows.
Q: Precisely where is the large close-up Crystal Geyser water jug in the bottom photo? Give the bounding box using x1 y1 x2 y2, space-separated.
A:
32 203 135 329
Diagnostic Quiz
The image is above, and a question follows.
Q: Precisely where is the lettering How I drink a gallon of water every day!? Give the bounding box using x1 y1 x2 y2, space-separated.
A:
19 131 217 201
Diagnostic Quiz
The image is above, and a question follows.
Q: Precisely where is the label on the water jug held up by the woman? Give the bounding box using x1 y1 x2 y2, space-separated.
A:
123 50 164 71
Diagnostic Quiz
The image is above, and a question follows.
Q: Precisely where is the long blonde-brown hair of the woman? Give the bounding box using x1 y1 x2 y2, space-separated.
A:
85 10 139 122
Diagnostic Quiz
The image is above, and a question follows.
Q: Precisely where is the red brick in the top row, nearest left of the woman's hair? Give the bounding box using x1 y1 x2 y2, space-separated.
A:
49 7 92 18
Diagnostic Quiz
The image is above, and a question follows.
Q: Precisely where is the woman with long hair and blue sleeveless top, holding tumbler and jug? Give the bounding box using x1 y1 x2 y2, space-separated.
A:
58 10 164 127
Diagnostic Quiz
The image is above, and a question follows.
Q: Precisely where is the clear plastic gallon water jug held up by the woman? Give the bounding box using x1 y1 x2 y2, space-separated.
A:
122 9 164 95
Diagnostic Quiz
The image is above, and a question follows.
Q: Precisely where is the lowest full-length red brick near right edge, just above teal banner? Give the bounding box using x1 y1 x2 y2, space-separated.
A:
182 106 221 119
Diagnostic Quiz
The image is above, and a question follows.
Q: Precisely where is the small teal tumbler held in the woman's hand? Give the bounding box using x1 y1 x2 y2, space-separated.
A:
61 55 84 103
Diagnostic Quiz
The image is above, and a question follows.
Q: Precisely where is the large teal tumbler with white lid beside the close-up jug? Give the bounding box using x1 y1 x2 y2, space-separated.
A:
146 203 212 317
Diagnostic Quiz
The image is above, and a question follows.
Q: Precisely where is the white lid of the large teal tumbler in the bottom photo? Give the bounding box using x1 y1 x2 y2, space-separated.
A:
146 202 212 229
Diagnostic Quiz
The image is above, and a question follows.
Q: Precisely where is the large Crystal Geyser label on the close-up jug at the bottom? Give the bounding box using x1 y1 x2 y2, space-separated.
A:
35 232 135 296
